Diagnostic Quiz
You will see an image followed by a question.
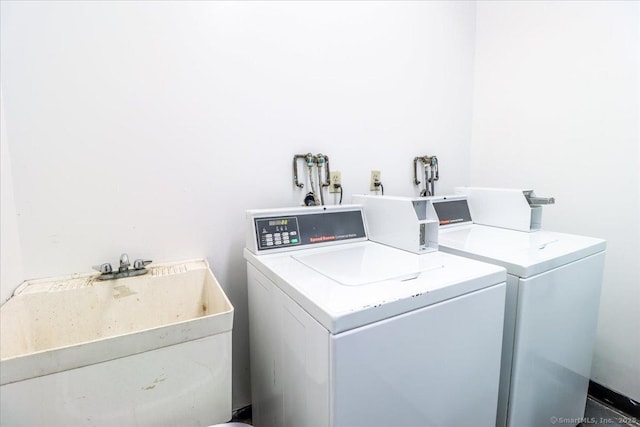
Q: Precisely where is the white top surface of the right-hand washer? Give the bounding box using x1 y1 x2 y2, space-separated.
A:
438 224 606 278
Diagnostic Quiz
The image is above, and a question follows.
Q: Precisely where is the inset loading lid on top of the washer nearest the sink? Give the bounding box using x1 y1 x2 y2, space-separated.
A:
292 245 444 286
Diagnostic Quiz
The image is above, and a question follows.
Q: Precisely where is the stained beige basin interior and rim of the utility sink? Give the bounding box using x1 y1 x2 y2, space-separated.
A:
0 259 233 384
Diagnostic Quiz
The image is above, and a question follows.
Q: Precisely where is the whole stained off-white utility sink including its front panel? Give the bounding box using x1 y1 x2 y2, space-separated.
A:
0 259 233 425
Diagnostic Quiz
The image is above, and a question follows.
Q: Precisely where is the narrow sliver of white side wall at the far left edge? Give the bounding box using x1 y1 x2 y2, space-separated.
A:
0 96 23 304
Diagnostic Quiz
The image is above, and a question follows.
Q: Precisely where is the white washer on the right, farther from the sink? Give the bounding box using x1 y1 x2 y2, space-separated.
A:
354 193 606 427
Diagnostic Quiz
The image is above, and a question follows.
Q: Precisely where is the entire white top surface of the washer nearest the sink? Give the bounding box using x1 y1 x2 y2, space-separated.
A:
244 241 506 334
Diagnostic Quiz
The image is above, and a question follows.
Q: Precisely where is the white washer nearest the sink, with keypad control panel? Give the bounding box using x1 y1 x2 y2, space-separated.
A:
244 206 506 427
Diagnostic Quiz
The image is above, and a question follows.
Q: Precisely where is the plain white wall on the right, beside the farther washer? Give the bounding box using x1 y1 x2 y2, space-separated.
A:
470 1 640 400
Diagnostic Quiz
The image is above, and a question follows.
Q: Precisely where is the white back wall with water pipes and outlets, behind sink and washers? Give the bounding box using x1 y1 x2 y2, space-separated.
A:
0 1 475 407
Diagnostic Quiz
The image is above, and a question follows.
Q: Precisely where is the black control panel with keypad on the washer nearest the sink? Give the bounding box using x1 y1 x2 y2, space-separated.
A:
255 210 367 250
